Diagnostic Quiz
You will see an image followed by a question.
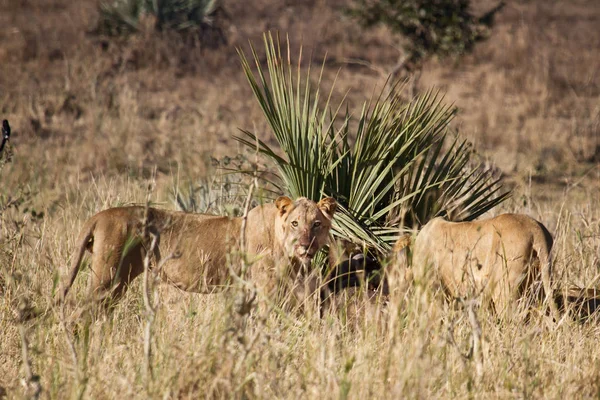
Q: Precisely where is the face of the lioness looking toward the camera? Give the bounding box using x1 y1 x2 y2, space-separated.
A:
275 197 337 265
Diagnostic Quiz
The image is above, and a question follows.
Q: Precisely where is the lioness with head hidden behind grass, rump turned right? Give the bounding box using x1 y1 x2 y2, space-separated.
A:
394 214 558 316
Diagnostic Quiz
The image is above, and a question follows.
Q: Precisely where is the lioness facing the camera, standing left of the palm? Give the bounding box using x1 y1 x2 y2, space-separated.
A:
62 197 337 306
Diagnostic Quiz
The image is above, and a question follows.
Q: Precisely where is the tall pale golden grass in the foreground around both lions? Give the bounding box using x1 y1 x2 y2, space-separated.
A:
0 173 600 398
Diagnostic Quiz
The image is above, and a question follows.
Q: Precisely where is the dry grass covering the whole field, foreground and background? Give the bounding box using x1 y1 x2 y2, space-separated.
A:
0 0 600 398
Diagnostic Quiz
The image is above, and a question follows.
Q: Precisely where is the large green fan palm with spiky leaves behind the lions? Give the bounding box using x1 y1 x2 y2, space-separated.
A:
236 34 508 253
